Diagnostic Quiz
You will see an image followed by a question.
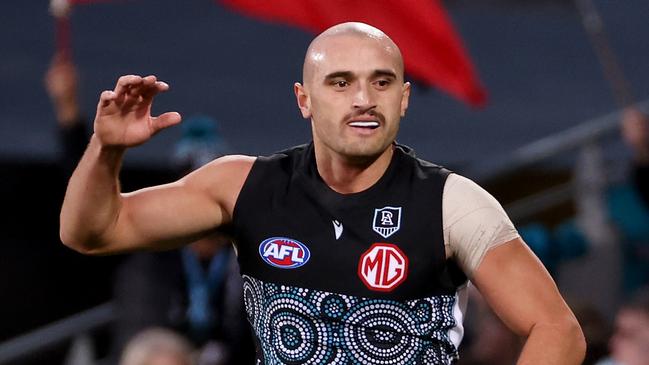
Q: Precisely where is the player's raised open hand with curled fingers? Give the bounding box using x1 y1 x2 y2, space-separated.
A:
95 75 181 148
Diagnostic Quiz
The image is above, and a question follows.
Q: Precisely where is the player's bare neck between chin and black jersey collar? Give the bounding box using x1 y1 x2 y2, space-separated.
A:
315 145 394 194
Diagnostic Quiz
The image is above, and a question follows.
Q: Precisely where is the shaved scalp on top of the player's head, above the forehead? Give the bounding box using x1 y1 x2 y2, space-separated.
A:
302 22 403 86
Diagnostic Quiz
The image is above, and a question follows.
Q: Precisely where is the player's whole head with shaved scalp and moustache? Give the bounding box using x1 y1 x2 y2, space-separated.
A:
294 23 410 161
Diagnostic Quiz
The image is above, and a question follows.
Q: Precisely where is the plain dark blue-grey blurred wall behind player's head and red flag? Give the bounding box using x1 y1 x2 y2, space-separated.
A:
0 0 649 165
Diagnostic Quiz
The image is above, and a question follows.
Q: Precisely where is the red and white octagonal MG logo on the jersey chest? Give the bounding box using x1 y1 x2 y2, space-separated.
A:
358 243 408 292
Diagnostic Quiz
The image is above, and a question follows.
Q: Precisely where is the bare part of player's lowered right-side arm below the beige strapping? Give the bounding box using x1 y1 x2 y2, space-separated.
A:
471 238 586 365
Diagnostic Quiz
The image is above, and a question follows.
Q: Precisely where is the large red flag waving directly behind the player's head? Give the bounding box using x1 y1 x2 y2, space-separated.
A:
221 0 486 106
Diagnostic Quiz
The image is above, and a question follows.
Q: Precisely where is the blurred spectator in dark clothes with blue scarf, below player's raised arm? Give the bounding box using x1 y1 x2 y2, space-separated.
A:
113 233 254 365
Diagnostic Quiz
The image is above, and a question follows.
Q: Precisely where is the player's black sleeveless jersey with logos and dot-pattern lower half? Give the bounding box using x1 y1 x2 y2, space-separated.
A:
232 144 466 364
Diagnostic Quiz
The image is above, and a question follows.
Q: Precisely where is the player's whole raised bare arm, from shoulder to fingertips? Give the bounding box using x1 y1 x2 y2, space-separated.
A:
60 75 254 254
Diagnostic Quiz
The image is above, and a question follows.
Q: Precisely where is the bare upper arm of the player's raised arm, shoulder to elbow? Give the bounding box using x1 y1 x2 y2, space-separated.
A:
102 158 252 252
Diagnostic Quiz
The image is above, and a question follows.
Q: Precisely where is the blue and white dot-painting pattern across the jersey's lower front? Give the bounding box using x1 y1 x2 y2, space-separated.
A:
243 275 458 365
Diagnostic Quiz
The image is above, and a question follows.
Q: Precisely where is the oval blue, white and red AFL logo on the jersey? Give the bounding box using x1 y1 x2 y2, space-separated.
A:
259 237 311 269
